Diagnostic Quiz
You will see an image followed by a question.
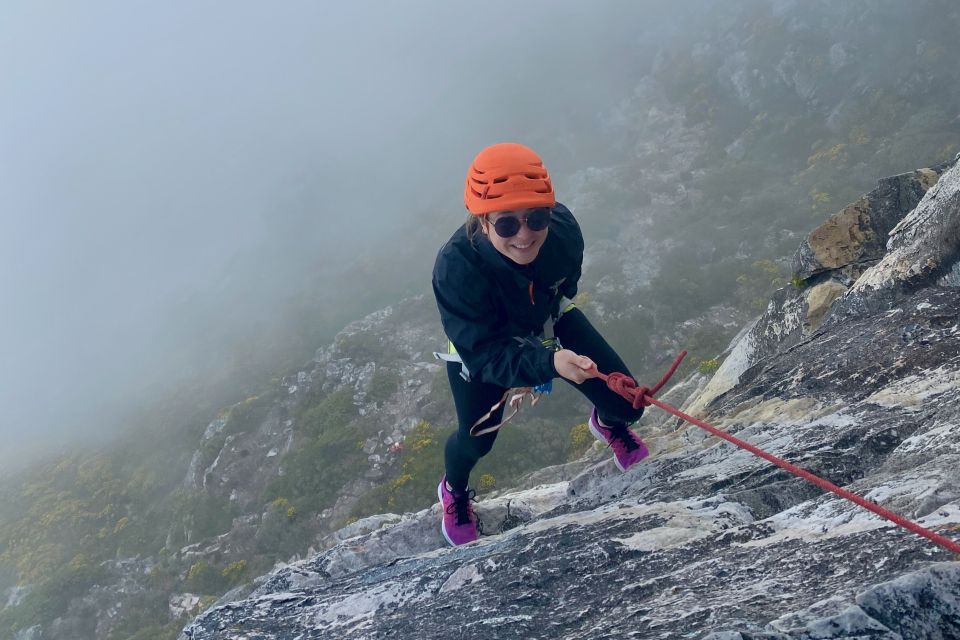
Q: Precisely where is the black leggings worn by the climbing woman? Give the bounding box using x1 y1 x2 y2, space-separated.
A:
444 308 643 491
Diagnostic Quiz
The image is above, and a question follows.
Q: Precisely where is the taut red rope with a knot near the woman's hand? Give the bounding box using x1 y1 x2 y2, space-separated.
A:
591 351 960 554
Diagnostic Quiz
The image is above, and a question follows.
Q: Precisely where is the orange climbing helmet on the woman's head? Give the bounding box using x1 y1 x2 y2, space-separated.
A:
463 142 557 216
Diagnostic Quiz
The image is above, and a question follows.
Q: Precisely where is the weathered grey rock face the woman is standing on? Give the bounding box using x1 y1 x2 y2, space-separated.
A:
181 162 960 640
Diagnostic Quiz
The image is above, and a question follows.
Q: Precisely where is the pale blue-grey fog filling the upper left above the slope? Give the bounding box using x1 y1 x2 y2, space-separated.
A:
0 0 676 466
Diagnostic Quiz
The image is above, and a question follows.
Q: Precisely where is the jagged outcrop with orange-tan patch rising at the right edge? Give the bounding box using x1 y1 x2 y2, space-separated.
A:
685 156 960 414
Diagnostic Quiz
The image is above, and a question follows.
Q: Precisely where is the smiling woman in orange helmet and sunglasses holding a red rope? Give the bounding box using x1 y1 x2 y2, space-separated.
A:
433 143 648 545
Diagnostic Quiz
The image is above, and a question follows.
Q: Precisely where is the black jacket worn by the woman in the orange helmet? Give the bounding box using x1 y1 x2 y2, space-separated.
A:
433 203 583 387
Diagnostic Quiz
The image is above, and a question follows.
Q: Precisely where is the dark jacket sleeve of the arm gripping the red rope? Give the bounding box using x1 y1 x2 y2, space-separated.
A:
433 269 557 387
